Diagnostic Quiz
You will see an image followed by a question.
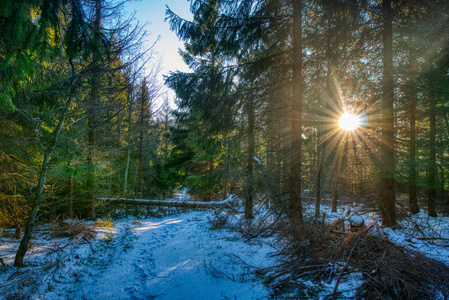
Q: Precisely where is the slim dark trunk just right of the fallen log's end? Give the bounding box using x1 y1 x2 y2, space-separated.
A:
245 94 255 220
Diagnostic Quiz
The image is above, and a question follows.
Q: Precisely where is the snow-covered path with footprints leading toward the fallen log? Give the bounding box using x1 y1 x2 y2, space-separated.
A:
67 212 270 300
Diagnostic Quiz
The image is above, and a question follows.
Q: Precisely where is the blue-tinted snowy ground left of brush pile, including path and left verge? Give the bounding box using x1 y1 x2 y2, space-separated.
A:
0 211 272 300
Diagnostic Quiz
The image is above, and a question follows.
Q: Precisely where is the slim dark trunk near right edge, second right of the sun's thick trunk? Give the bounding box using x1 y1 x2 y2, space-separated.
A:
427 97 437 217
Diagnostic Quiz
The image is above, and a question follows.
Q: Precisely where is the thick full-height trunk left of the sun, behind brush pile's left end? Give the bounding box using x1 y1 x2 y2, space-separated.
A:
289 0 304 221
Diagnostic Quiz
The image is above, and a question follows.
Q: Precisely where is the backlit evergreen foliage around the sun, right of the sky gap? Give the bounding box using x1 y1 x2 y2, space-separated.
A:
167 0 447 220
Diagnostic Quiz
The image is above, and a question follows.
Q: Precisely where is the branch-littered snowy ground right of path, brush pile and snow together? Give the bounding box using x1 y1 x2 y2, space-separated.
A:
258 205 449 299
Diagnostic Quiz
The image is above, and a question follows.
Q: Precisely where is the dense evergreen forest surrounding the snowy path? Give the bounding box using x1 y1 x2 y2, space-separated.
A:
0 0 449 299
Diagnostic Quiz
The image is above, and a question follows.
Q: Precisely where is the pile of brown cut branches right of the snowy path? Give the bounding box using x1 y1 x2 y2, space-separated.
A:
261 222 449 299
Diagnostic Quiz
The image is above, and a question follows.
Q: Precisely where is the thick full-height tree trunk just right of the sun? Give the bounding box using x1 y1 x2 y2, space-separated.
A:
379 0 396 227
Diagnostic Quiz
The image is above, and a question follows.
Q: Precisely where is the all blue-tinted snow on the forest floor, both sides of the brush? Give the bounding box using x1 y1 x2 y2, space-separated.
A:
0 198 449 300
